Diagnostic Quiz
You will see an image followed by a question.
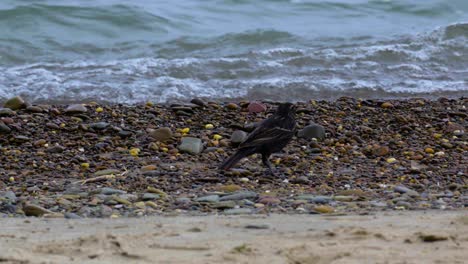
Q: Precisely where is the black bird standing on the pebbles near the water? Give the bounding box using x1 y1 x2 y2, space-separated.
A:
219 103 296 175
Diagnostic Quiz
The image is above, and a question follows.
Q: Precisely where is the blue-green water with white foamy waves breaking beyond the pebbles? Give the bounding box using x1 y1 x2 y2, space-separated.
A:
0 0 468 103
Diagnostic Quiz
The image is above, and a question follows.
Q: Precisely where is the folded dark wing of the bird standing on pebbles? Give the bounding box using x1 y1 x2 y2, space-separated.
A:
239 127 294 148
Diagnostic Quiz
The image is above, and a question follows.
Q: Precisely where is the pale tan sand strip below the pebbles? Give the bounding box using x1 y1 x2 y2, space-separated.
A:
0 210 468 264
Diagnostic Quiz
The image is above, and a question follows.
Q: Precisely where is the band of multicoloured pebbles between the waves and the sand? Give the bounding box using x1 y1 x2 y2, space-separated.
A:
0 97 468 218
